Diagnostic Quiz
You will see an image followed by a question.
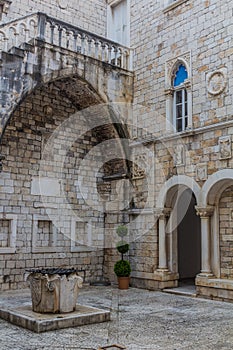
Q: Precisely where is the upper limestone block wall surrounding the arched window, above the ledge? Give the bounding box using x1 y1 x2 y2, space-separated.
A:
131 0 233 136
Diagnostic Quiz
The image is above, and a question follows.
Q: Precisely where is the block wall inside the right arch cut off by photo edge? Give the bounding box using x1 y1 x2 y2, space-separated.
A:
219 186 233 279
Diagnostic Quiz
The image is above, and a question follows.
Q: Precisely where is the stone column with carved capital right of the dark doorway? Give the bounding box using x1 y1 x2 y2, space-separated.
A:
196 206 213 276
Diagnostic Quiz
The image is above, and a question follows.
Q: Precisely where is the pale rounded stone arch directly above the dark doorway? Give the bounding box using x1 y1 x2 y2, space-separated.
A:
156 175 200 208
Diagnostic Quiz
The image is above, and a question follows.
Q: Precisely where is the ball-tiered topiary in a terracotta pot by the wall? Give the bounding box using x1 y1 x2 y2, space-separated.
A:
114 225 131 289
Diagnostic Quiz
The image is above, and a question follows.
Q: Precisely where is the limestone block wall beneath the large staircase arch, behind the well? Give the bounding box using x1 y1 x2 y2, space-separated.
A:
0 84 104 290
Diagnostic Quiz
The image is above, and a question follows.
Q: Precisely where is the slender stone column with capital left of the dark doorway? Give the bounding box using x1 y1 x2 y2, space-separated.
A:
158 208 171 271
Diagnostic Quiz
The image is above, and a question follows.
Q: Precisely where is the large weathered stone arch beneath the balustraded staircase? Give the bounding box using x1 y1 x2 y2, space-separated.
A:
0 65 129 140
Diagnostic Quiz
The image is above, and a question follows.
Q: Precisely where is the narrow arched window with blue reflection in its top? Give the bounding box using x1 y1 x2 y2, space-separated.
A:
173 64 188 132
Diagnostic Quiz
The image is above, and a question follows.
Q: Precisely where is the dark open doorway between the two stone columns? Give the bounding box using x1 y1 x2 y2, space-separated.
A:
177 189 201 284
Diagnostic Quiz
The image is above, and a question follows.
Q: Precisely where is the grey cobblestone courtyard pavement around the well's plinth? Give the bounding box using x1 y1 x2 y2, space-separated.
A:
0 287 233 350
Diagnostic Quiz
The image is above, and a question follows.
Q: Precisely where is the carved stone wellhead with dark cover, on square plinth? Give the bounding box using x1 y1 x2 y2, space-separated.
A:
27 268 83 313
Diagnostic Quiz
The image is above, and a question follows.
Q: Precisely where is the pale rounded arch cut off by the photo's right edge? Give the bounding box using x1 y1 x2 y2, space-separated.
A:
199 169 233 206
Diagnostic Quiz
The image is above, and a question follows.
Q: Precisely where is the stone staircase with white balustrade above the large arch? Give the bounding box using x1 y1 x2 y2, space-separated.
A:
0 12 132 134
